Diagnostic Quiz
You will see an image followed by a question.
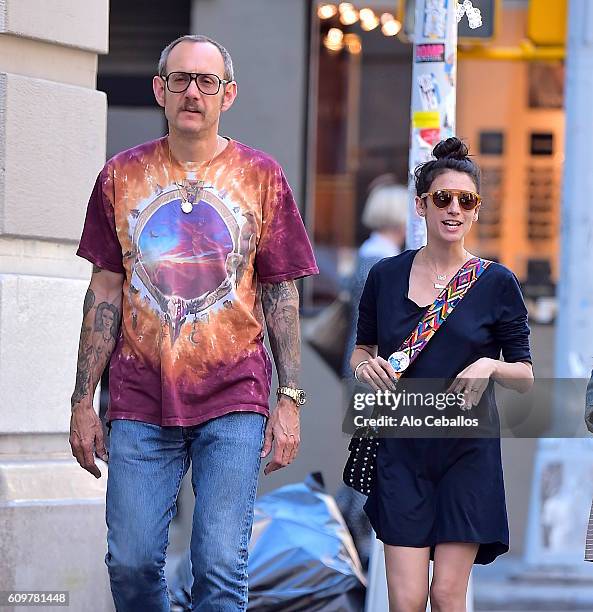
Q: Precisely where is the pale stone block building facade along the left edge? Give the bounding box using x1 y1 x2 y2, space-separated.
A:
0 0 113 610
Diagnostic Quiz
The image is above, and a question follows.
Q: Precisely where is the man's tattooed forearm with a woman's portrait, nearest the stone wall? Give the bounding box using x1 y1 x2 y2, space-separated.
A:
71 287 121 409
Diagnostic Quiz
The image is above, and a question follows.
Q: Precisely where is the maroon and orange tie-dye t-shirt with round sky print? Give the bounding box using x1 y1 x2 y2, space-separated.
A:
78 138 318 426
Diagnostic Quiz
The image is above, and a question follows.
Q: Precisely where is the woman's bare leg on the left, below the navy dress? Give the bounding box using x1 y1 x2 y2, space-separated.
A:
385 544 430 612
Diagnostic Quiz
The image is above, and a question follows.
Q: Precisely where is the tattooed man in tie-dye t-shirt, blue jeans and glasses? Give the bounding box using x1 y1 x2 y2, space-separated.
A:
70 36 317 612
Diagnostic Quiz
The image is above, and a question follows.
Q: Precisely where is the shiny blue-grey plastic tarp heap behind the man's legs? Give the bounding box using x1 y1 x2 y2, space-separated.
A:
170 476 366 612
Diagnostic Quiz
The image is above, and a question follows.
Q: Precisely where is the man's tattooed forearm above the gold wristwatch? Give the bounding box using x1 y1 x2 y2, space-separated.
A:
262 281 301 387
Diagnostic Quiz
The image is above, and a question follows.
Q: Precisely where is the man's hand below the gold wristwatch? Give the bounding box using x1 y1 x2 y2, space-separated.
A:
261 396 301 475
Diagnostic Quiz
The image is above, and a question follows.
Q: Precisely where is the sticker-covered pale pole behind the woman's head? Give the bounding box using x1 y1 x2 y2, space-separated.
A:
406 0 457 248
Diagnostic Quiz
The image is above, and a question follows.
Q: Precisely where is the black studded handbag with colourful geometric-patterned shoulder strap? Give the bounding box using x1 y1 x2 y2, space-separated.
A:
342 257 492 495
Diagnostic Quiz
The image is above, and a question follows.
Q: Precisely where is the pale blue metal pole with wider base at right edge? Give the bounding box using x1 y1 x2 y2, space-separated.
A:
526 0 593 570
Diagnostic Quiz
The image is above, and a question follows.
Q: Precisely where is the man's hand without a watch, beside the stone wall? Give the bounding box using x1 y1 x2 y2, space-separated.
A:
70 404 107 478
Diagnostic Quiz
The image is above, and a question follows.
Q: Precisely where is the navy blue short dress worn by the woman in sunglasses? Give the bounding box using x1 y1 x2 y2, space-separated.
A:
357 251 531 564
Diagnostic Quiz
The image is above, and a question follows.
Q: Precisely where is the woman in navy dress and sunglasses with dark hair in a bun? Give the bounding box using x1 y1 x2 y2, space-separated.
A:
350 138 533 612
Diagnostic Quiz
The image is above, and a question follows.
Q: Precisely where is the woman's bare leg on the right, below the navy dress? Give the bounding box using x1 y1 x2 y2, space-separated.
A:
430 542 479 612
